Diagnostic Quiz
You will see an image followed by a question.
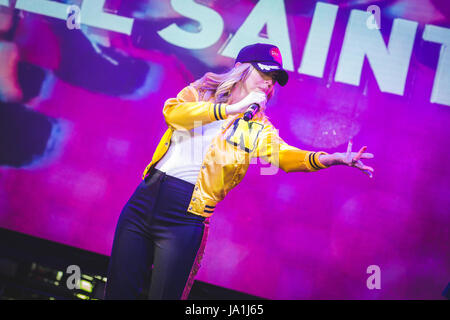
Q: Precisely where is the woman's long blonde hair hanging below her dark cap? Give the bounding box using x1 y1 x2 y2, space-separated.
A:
191 63 273 103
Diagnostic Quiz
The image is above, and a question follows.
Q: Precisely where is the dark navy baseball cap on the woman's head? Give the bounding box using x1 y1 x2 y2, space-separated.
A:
234 43 289 86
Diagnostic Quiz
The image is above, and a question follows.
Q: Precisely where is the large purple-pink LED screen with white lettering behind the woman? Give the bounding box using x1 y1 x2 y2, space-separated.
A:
0 0 450 299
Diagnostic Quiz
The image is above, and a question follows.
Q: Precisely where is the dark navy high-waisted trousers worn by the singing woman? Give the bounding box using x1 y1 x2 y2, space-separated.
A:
105 169 209 300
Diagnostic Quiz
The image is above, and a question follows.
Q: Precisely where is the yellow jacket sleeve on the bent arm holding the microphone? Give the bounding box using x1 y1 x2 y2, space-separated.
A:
163 86 227 130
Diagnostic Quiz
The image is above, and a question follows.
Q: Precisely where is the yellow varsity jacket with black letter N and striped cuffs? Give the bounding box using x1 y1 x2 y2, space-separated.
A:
142 86 328 217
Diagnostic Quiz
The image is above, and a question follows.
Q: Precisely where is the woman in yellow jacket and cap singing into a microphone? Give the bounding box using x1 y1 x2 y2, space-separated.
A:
105 43 374 299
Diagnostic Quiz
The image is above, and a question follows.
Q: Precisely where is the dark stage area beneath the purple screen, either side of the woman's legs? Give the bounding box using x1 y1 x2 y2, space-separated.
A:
0 228 261 300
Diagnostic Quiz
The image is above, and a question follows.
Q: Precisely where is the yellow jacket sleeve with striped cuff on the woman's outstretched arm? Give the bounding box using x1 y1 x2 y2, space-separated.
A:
256 119 328 172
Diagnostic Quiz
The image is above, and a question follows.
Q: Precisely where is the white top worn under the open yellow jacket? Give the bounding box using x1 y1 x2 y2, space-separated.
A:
155 120 225 184
